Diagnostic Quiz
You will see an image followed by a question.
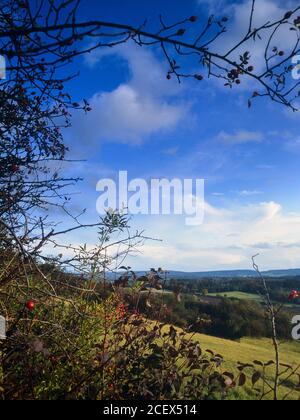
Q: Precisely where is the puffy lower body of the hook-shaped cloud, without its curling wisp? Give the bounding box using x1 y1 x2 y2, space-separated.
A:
73 85 185 144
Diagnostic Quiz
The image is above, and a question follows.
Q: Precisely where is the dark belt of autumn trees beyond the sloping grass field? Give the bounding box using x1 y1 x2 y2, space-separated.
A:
140 286 297 340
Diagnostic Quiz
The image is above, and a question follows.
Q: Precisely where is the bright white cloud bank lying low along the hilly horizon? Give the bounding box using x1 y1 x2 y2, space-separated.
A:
122 202 300 271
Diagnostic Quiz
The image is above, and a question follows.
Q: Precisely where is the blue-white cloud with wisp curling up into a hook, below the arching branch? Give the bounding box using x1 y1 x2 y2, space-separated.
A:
72 45 188 144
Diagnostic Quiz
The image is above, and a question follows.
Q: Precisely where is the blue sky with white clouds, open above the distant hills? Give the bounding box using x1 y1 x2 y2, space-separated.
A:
48 0 300 271
